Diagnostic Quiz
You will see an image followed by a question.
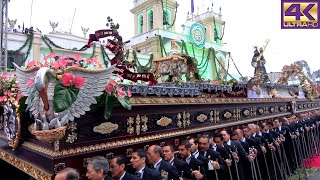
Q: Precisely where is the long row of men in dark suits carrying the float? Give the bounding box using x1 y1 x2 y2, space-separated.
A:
55 111 320 180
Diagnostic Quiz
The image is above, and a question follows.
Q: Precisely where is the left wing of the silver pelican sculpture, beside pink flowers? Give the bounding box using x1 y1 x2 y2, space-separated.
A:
14 63 42 115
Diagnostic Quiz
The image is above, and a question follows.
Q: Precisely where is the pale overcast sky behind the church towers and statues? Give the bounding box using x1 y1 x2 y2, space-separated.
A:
8 0 320 76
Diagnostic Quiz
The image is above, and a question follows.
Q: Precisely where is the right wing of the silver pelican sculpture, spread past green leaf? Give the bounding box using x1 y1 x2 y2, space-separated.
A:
59 66 116 126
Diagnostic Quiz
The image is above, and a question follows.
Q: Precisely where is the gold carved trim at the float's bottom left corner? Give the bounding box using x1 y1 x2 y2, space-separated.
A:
0 149 52 180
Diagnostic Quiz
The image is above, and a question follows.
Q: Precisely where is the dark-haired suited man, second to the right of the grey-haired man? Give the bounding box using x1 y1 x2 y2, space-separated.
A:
130 149 161 180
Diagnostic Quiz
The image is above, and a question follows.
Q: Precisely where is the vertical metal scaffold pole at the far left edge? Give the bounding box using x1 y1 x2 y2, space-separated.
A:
0 0 9 72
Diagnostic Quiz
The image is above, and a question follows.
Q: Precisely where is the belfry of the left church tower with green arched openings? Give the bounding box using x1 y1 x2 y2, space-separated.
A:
131 0 178 36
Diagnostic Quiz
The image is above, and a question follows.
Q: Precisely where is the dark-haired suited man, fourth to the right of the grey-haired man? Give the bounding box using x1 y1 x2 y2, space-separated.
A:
162 144 189 177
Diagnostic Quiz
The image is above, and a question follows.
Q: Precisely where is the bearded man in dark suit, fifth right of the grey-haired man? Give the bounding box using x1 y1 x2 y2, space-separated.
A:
178 140 206 180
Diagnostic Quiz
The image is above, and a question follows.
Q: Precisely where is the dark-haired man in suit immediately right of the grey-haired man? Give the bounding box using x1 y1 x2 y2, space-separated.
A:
110 155 140 180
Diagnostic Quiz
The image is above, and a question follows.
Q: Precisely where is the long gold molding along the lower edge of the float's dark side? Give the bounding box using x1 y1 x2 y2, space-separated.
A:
22 108 320 157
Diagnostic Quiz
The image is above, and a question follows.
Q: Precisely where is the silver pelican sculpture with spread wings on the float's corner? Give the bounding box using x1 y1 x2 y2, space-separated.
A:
15 64 115 130
